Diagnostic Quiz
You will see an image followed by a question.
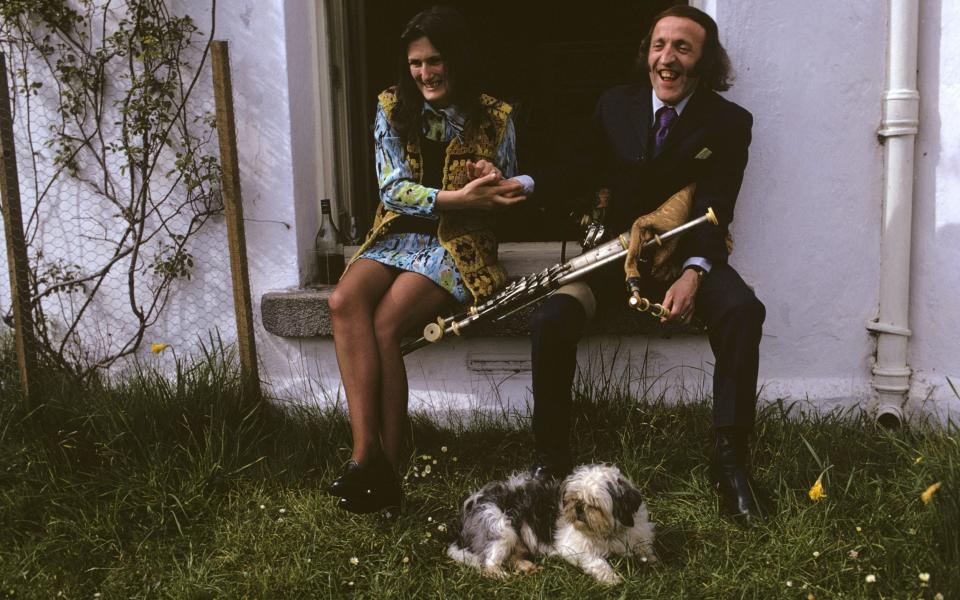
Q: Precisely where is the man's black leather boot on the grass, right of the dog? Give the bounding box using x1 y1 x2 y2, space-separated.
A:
710 428 761 526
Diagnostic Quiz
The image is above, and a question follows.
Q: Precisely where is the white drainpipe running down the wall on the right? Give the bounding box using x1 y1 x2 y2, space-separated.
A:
867 0 920 425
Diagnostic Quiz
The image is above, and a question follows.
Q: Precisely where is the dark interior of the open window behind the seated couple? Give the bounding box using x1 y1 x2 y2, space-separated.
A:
355 0 685 241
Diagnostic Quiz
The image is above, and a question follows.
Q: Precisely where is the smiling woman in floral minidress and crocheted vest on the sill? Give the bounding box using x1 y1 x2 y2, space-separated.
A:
329 7 525 513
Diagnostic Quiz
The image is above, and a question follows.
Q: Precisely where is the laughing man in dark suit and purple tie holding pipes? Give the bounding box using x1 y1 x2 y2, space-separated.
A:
527 6 765 521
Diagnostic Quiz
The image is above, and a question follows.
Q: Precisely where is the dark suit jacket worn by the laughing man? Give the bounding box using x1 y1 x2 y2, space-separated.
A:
534 83 753 264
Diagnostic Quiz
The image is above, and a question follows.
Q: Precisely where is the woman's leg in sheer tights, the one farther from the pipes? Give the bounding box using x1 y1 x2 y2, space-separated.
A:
329 259 399 464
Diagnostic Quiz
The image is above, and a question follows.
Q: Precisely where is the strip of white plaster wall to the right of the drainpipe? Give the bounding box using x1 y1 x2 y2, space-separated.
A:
910 0 960 419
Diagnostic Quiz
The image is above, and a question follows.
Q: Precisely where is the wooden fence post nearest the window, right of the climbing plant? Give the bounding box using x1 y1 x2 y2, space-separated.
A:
211 41 260 398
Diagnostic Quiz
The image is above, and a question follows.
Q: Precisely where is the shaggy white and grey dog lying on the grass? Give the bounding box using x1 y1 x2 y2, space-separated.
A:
447 465 657 584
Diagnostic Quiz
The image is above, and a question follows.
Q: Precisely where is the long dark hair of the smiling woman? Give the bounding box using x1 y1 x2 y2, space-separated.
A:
393 6 486 140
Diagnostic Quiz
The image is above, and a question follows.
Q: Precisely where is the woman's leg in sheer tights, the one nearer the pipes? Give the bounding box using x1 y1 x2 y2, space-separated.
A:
374 272 451 469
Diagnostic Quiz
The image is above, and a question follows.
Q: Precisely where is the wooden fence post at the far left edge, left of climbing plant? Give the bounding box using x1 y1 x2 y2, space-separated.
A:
0 52 37 408
